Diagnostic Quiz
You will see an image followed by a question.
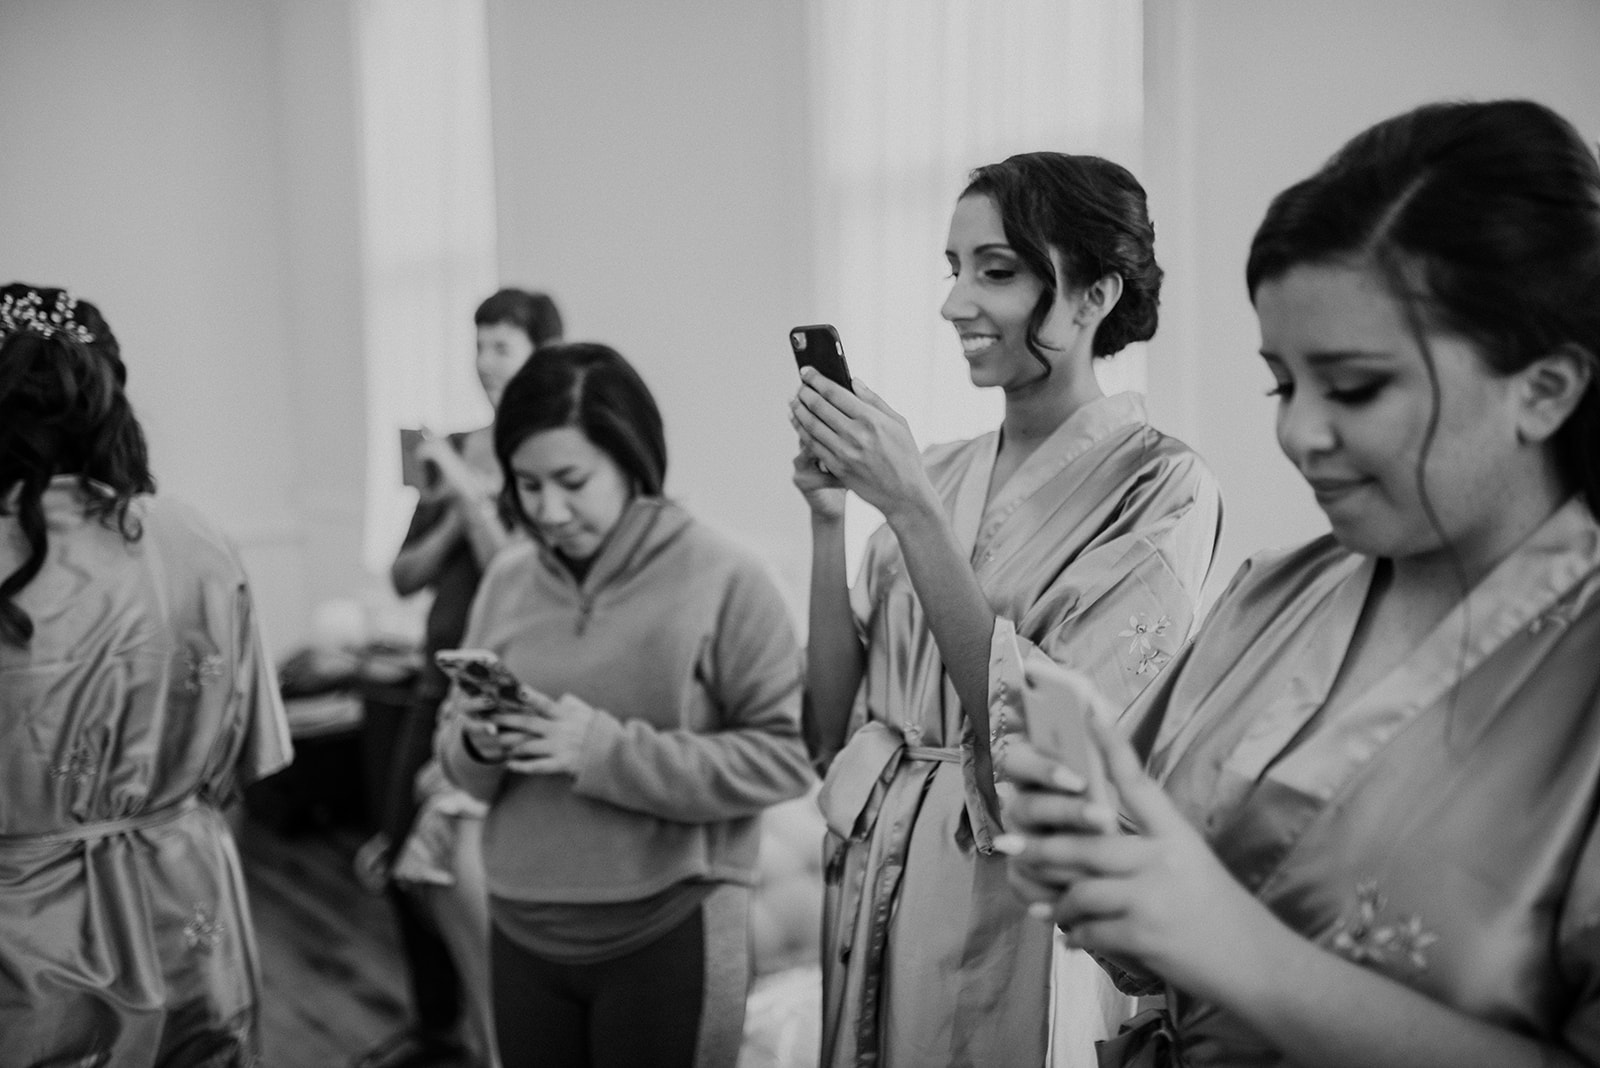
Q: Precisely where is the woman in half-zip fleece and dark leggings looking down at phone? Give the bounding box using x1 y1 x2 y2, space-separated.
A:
438 344 811 1068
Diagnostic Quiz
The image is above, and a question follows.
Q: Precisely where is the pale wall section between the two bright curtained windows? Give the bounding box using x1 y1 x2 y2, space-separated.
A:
490 0 816 604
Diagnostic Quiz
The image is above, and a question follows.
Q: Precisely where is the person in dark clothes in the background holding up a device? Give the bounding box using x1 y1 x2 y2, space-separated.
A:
352 288 562 1068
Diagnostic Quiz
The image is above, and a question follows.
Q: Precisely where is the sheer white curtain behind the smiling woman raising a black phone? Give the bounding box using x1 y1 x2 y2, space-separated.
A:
808 0 1144 572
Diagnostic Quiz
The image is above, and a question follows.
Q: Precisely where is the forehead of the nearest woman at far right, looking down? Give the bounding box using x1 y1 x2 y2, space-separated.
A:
1254 264 1416 360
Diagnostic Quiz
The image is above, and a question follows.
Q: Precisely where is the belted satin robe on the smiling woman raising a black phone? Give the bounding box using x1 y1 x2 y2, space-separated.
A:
819 393 1221 1068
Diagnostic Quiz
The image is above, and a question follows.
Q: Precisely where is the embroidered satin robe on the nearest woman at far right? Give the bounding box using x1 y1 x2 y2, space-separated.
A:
1102 499 1600 1068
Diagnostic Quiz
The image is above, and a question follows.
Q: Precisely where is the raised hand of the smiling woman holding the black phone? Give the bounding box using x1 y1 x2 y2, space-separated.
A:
789 368 933 516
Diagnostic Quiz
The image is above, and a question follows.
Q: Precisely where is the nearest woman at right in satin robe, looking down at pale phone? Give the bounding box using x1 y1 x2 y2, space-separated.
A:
1005 101 1600 1068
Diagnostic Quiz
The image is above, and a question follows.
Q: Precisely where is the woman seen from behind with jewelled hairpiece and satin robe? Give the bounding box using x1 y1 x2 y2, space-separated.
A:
0 283 290 1068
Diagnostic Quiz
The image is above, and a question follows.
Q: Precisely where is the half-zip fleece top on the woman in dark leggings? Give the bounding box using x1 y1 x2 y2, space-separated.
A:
438 497 811 903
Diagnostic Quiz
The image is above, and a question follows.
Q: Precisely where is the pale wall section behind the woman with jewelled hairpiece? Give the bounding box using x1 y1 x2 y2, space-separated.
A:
0 0 363 649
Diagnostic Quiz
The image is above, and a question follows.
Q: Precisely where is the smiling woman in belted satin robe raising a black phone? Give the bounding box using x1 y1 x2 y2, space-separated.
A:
790 152 1221 1068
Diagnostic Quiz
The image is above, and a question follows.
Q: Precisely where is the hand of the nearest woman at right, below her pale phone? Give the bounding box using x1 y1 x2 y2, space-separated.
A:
995 719 1275 996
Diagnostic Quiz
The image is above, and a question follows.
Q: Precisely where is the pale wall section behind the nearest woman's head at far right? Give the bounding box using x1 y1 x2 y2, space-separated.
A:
1144 0 1600 579
